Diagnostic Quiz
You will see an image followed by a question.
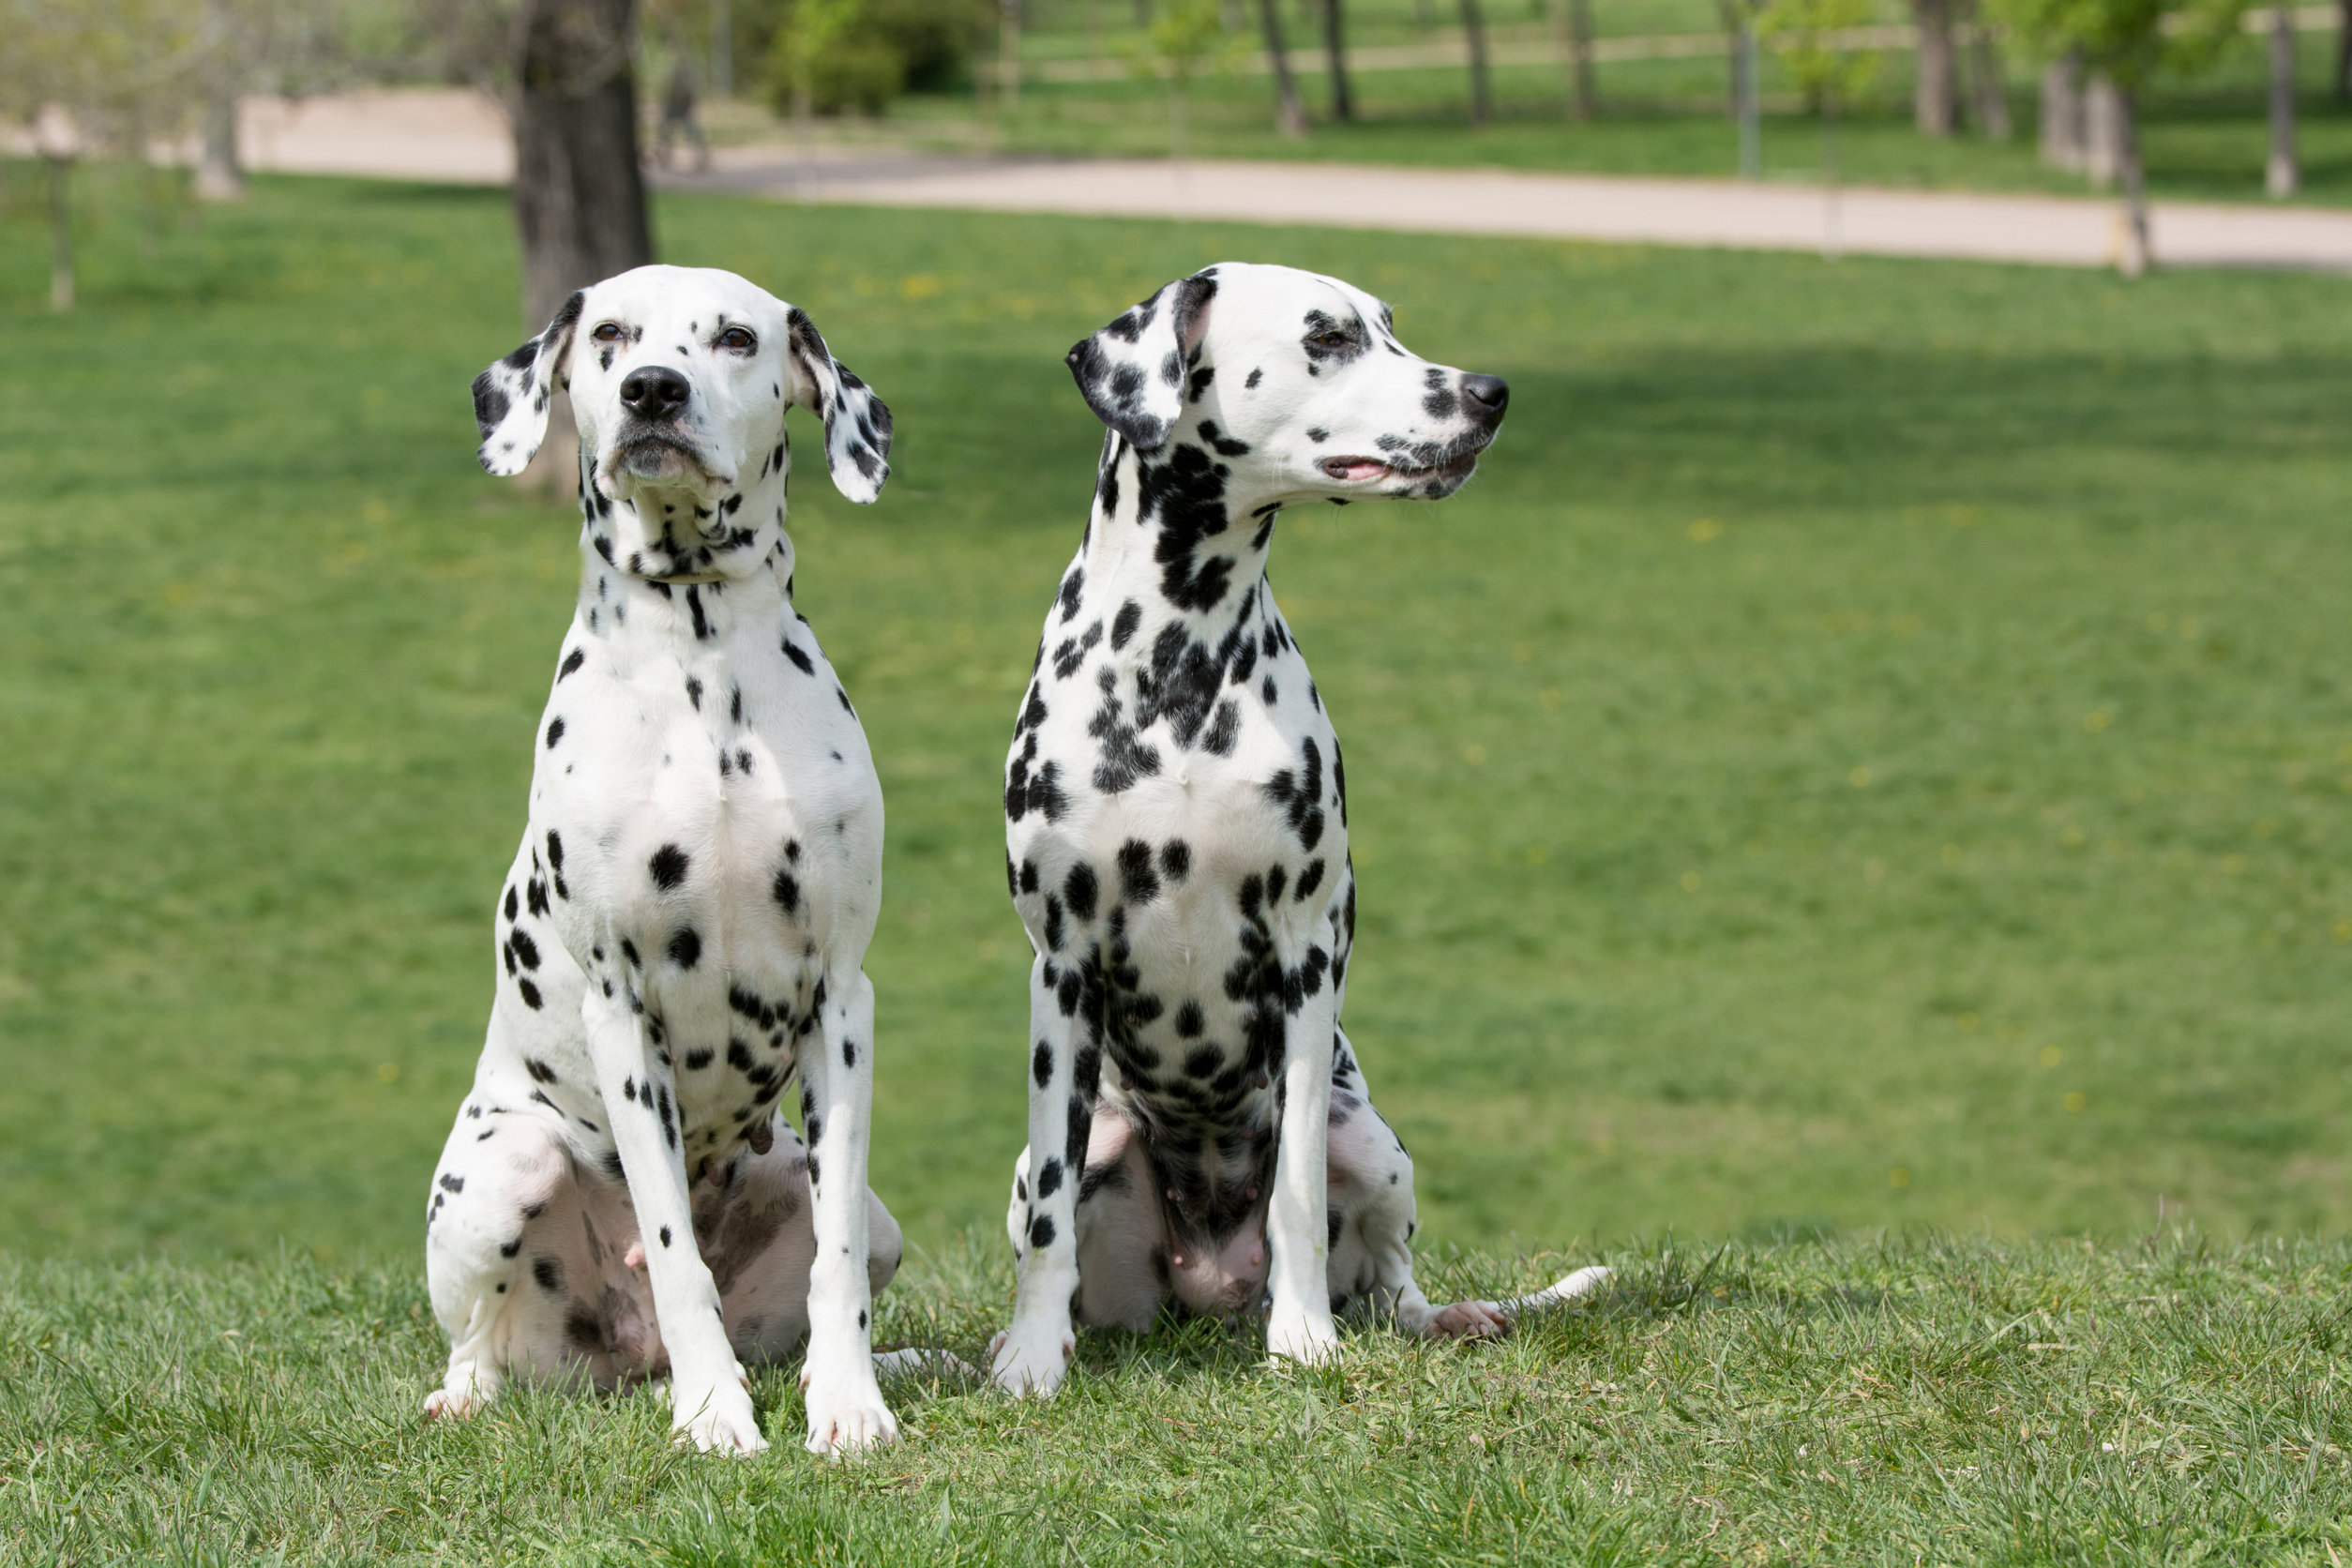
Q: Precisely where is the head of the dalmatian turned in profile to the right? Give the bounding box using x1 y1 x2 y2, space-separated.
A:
1070 261 1510 503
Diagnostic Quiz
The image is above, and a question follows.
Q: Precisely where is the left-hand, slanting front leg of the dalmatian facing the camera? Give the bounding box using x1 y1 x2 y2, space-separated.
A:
580 988 767 1453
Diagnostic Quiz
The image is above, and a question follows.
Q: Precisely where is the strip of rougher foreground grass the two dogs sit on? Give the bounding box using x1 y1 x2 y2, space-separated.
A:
0 1237 2352 1568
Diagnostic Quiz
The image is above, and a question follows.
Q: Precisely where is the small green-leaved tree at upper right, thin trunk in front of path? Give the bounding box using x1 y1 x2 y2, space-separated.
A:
1992 0 2246 278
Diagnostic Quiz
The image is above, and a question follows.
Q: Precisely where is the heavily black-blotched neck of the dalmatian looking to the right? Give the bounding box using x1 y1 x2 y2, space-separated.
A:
1056 435 1282 660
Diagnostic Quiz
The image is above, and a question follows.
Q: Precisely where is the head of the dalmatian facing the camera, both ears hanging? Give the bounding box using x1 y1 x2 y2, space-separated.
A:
473 265 892 515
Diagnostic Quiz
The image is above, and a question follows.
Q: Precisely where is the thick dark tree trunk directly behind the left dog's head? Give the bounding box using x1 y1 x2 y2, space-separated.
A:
513 0 654 493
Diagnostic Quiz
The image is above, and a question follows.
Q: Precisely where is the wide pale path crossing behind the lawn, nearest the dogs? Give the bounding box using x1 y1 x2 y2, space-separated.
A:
229 92 2352 270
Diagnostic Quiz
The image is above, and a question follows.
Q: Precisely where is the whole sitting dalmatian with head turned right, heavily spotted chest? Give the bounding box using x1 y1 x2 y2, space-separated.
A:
992 264 1608 1395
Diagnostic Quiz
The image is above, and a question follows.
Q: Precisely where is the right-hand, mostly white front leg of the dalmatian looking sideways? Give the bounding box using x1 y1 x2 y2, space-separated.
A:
1265 972 1338 1364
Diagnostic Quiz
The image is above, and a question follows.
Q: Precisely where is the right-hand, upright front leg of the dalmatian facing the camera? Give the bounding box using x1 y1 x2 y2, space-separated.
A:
800 969 898 1455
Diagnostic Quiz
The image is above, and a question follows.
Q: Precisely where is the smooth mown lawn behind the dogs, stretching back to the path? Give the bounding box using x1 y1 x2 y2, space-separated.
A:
0 184 2352 1258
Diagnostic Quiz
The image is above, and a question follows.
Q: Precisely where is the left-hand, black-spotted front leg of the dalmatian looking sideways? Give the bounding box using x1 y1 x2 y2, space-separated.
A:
990 955 1101 1395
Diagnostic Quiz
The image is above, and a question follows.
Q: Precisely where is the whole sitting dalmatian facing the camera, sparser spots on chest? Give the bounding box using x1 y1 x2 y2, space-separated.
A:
426 265 898 1453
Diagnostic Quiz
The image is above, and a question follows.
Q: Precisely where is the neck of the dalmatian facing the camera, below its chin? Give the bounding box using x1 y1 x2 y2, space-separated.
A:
580 446 792 593
